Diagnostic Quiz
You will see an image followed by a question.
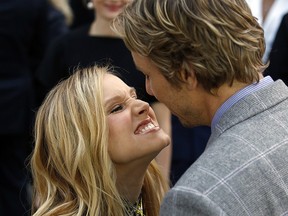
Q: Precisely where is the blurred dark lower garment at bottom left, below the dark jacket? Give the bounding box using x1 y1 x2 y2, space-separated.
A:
0 134 31 216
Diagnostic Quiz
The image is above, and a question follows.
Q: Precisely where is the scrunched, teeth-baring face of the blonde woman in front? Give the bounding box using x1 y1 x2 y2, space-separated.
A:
103 74 170 164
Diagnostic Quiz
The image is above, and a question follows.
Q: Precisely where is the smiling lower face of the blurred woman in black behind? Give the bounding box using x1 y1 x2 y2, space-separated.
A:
93 0 130 20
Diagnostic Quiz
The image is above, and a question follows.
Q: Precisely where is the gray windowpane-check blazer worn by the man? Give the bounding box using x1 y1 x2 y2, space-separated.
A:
160 80 288 216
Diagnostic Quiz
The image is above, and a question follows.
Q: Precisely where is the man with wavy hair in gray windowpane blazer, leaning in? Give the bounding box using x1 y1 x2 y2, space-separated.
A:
114 0 288 216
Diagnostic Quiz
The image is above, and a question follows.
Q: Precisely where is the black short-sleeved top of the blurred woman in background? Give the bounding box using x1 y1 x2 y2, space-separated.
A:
37 25 156 104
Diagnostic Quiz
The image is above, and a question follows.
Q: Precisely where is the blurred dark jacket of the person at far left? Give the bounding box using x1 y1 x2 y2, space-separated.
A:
0 0 67 134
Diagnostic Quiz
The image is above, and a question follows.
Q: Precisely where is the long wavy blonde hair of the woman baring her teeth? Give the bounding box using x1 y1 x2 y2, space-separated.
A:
31 66 168 216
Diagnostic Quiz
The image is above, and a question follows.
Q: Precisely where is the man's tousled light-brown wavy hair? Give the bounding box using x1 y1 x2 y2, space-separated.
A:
113 0 266 91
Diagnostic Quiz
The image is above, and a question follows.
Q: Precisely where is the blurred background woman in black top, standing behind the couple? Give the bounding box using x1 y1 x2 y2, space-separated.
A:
36 0 172 180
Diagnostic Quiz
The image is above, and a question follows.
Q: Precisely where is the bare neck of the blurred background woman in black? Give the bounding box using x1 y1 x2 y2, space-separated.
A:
89 19 118 37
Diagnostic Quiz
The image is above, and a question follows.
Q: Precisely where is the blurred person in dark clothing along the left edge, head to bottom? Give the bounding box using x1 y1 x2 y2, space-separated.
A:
0 0 68 216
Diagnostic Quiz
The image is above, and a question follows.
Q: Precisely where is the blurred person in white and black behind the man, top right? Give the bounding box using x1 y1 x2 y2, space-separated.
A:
247 0 288 84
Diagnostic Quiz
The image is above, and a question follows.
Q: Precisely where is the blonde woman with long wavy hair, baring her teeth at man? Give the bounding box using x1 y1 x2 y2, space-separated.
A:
31 66 170 216
